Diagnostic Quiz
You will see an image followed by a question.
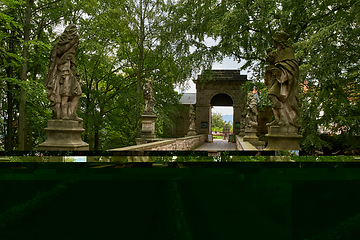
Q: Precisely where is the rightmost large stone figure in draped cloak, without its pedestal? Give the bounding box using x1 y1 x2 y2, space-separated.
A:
265 32 299 128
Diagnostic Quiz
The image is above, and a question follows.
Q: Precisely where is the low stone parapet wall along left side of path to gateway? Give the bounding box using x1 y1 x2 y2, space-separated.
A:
108 134 206 151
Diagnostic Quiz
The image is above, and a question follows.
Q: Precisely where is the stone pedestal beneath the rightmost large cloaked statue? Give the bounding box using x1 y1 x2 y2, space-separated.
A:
265 125 302 151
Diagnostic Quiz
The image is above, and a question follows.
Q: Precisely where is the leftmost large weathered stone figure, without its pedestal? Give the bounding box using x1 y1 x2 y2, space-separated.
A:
45 24 82 122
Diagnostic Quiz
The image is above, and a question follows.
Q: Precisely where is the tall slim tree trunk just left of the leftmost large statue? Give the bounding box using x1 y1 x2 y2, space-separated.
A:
18 0 33 151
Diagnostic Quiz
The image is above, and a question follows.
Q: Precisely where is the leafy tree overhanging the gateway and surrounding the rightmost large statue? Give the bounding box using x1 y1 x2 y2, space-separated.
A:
184 0 360 151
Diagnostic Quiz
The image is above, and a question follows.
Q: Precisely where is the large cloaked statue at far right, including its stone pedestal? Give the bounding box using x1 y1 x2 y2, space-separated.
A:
265 32 302 150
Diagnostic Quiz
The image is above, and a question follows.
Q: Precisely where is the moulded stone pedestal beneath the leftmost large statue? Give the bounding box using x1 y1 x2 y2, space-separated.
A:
38 120 89 151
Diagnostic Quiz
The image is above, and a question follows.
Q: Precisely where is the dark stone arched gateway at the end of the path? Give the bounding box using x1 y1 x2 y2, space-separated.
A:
194 70 248 135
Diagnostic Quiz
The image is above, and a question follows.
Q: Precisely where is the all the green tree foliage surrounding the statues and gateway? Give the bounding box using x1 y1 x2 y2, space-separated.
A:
0 0 360 152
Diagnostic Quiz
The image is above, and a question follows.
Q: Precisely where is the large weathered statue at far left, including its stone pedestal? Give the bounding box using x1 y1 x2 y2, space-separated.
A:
38 24 89 151
